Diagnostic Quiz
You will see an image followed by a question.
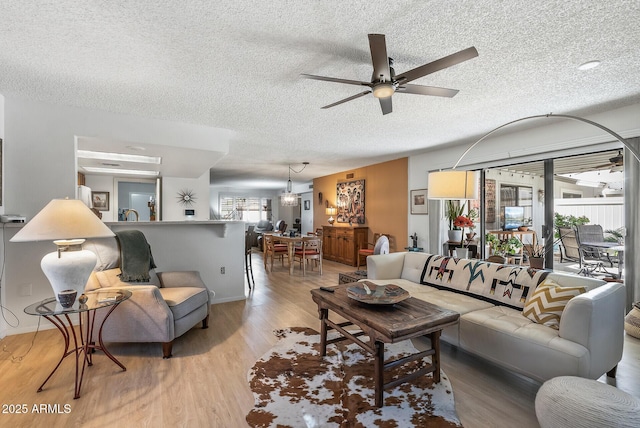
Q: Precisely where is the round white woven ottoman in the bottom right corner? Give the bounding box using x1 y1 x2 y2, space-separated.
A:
536 376 640 428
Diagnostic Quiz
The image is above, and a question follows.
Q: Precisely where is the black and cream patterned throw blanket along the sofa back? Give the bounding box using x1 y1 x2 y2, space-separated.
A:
420 255 549 310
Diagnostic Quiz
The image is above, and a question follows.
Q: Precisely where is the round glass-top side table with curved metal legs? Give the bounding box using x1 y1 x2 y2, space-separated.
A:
24 290 131 399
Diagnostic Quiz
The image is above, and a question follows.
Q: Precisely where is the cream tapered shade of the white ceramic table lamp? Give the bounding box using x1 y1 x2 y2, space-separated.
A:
11 199 114 242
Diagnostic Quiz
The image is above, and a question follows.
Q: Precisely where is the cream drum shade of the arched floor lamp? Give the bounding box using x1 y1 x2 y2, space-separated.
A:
428 170 480 199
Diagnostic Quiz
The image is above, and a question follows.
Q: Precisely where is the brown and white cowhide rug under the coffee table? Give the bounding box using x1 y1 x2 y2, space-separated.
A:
247 328 462 428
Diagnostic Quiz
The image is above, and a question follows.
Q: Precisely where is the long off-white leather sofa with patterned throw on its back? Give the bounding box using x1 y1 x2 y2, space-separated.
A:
367 252 625 382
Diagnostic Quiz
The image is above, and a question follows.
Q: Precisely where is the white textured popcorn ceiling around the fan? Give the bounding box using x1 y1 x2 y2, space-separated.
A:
0 0 640 187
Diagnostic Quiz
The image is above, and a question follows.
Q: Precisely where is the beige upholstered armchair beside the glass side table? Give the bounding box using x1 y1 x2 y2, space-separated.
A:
84 234 211 358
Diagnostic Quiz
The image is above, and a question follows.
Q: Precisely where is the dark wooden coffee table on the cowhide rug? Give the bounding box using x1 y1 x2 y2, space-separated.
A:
311 284 460 407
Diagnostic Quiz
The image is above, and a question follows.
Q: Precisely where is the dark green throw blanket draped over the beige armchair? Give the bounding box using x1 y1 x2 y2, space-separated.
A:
116 230 156 282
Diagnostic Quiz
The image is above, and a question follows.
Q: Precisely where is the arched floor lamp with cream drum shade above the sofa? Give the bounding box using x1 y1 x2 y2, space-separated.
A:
428 113 640 199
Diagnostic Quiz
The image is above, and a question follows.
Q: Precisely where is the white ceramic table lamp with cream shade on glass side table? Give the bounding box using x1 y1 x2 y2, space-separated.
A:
10 199 114 301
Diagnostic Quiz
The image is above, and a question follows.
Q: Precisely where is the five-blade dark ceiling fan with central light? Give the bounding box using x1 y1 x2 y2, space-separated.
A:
301 34 478 115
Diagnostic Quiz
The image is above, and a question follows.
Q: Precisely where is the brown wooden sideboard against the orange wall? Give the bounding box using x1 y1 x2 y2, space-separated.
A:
322 226 369 266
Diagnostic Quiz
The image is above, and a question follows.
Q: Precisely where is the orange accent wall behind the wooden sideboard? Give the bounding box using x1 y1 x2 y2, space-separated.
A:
313 158 409 252
